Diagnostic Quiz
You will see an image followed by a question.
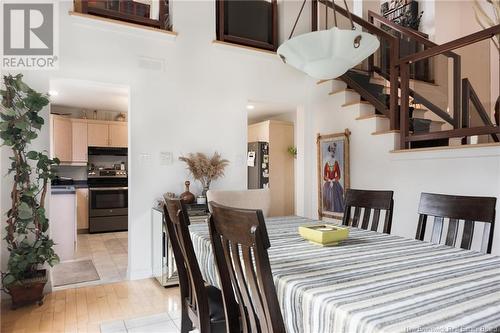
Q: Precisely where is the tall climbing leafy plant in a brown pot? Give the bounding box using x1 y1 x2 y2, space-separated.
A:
0 74 59 308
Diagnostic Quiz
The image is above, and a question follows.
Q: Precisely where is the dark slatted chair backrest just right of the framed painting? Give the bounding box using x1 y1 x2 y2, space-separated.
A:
342 189 394 234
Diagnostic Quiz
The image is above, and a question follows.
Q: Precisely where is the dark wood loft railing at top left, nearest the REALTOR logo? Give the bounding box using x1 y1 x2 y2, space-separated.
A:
74 0 172 30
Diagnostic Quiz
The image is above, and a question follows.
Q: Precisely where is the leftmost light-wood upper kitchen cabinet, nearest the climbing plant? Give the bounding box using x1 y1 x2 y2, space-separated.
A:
51 115 73 163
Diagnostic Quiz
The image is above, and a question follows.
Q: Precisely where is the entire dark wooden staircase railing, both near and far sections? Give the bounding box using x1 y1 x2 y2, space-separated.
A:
311 0 500 149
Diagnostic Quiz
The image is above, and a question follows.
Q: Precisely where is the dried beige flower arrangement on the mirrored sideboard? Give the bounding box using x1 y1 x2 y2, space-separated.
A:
179 152 229 197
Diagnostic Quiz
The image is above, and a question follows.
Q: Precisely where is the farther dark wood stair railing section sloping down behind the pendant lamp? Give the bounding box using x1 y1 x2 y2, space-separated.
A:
311 0 399 130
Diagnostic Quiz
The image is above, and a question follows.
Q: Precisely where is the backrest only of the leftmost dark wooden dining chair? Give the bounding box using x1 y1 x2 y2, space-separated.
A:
164 198 210 327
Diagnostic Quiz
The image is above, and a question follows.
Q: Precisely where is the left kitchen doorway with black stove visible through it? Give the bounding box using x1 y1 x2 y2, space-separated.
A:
49 79 129 290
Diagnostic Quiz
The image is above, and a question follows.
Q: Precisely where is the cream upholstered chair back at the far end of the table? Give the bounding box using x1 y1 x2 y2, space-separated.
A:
207 189 271 217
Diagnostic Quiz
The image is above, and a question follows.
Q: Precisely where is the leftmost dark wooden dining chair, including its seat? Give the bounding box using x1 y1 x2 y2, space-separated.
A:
163 199 226 333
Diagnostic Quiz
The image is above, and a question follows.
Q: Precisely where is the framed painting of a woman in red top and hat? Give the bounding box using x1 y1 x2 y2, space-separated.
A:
316 129 351 220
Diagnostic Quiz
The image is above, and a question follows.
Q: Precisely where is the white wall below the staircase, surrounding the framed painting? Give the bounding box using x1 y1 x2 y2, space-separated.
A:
297 79 500 254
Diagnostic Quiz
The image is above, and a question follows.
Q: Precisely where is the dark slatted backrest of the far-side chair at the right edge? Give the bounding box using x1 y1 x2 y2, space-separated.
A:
415 193 497 253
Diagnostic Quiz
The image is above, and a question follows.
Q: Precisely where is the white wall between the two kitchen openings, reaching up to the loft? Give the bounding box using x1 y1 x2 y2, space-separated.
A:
1 1 306 278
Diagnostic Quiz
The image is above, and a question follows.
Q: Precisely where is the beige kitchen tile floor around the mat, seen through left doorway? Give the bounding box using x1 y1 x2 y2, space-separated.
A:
54 231 128 290
